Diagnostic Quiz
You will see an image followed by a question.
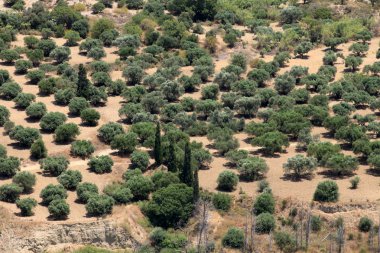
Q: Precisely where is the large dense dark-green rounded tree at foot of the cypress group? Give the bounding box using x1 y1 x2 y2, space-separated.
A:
143 184 194 228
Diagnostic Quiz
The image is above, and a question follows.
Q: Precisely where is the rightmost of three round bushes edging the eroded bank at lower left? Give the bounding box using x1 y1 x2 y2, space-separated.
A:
86 195 115 216
